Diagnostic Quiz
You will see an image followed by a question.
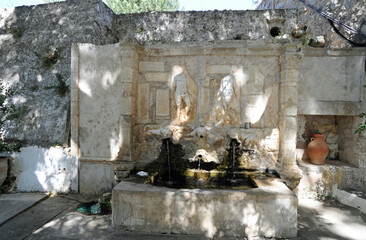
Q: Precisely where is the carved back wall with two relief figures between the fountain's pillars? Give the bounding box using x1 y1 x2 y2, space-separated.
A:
132 42 280 172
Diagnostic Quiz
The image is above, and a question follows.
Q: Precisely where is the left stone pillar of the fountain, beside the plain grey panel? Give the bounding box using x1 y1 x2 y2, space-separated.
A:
115 44 138 180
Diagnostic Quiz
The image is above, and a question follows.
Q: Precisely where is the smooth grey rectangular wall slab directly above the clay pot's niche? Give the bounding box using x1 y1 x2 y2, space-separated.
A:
298 56 365 102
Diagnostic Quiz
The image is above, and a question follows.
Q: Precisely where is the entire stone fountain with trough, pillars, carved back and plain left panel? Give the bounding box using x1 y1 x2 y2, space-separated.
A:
71 41 301 238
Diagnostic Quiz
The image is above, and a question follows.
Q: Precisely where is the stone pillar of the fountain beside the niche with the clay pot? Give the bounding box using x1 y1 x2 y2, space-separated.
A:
278 45 302 189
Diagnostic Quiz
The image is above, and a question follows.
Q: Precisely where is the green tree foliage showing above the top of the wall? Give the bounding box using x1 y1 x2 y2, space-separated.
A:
104 0 179 13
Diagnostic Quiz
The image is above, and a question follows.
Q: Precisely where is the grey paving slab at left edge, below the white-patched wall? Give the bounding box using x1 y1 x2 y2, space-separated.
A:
0 193 47 226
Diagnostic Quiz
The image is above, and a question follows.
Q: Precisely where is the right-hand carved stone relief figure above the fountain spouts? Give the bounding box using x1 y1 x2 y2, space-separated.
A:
213 74 240 126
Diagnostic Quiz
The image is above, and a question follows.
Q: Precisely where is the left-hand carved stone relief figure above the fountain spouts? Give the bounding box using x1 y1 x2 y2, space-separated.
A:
172 66 197 125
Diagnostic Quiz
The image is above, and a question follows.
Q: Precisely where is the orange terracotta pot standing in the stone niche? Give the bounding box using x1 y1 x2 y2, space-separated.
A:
308 134 329 165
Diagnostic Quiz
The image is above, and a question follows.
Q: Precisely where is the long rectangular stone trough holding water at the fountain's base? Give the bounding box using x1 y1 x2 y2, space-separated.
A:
112 179 298 238
